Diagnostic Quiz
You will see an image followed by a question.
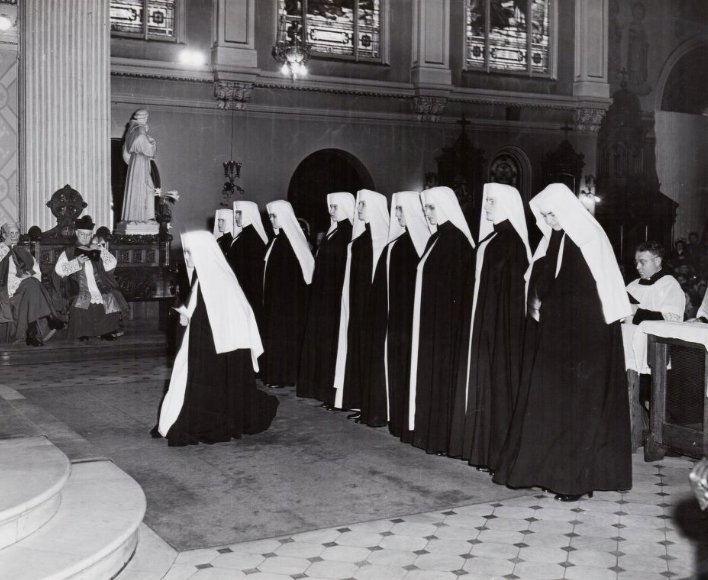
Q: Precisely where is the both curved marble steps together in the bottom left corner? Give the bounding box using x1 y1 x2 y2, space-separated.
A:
0 458 145 580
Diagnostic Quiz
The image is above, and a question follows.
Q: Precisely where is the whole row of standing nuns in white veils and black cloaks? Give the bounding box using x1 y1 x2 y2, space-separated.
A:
209 183 632 501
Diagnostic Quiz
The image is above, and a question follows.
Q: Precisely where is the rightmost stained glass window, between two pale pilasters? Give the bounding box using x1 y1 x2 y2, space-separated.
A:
466 0 552 75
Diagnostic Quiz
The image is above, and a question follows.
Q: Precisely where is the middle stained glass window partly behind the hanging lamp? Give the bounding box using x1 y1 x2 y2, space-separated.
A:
278 0 383 60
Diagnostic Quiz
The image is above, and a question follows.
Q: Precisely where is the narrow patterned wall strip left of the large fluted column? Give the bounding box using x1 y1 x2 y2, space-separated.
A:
0 44 17 229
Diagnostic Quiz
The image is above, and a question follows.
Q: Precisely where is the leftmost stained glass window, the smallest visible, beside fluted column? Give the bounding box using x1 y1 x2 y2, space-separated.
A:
111 0 176 39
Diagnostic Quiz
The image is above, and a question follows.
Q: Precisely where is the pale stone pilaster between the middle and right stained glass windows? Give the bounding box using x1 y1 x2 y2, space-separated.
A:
411 0 452 86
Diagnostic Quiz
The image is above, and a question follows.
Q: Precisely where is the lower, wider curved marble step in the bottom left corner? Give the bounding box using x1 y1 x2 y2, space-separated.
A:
0 461 145 580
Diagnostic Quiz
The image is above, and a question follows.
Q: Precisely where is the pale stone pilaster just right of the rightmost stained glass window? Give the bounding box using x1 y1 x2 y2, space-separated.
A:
573 0 610 98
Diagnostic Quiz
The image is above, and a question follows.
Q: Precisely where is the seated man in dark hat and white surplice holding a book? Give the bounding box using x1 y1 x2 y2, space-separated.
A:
53 216 129 341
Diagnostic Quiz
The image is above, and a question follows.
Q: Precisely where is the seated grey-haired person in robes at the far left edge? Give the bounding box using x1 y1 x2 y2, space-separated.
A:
0 223 61 346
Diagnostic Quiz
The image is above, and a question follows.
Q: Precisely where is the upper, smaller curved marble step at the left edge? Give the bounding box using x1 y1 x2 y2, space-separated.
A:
0 436 71 552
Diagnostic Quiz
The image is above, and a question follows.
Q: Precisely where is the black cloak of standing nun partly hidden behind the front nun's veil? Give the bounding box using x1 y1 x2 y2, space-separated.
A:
228 224 266 326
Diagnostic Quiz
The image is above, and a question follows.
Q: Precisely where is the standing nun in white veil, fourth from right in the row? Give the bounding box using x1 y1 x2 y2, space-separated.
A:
362 191 430 436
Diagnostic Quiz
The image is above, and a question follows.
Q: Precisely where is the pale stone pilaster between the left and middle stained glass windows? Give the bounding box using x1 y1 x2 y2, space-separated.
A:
211 0 258 78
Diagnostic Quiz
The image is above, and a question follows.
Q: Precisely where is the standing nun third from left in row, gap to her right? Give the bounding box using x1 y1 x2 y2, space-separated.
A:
261 200 315 387
